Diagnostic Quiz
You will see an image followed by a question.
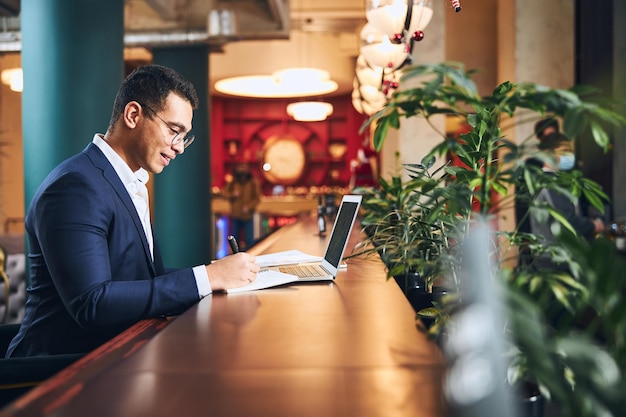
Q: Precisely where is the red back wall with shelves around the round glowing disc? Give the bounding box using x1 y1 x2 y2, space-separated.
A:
211 96 366 194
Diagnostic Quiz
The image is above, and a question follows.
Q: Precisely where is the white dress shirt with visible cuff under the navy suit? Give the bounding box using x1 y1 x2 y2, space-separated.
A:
93 133 212 298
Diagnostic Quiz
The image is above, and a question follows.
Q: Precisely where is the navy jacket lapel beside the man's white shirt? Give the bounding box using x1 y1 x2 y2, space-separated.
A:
83 143 157 275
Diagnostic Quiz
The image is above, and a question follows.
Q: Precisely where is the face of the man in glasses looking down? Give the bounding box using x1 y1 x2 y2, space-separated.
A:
131 93 193 174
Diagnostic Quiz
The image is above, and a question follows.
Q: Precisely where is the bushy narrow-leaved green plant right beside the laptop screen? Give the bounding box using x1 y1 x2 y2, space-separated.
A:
351 155 449 293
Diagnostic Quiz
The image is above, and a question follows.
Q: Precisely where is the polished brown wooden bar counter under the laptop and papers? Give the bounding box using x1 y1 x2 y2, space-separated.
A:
0 216 445 417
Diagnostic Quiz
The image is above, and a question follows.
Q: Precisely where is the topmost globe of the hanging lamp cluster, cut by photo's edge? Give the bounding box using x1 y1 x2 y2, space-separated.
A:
365 0 433 39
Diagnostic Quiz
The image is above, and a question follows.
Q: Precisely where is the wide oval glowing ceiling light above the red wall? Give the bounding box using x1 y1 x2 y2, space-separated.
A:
215 68 338 98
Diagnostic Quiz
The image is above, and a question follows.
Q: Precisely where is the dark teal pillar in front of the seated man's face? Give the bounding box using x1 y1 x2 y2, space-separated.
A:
152 45 213 268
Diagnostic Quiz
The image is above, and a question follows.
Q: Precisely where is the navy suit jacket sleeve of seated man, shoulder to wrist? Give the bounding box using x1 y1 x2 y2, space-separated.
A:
28 162 199 327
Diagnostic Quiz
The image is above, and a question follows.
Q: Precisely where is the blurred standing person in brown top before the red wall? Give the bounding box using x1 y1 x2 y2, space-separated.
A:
224 163 261 249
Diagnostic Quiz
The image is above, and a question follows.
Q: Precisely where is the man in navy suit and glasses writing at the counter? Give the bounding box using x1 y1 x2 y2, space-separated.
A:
7 65 259 357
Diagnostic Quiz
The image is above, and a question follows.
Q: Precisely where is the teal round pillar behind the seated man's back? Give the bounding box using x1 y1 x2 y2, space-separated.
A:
21 0 124 211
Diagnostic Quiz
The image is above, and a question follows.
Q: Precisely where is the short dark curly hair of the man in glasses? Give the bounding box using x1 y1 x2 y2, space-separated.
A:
109 64 199 128
